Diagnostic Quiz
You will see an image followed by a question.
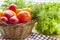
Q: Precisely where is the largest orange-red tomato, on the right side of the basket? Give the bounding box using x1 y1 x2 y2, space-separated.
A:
17 11 32 22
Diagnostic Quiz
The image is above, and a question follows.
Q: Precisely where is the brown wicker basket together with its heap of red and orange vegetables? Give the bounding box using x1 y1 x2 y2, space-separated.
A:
0 5 35 40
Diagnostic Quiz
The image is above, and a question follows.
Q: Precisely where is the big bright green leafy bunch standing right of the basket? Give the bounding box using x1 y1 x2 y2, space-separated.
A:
35 3 60 35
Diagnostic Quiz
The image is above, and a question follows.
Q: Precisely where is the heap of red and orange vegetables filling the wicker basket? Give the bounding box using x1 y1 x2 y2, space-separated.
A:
1 4 32 24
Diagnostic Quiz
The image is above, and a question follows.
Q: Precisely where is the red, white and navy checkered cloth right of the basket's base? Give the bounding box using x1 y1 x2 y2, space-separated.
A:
24 33 57 40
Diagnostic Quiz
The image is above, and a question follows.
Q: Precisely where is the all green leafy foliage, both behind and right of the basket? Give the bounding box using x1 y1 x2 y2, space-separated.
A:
2 0 60 35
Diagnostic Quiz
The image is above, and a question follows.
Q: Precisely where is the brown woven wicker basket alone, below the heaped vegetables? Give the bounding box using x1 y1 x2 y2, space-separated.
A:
0 21 35 40
